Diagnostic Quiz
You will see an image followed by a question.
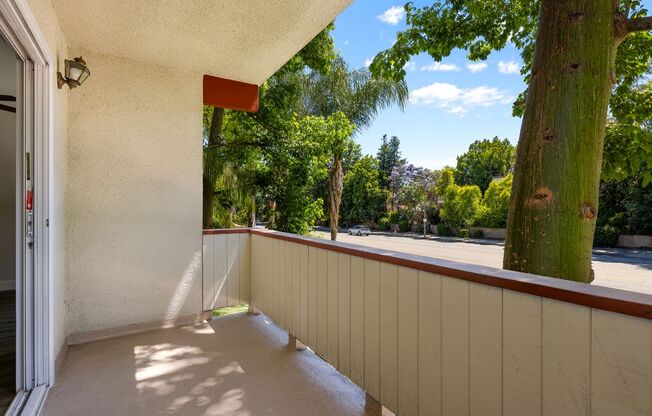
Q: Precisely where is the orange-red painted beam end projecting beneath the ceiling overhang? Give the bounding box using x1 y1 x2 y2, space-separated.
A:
204 75 258 113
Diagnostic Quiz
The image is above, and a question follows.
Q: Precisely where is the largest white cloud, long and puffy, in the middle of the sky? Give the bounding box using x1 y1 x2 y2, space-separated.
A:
410 82 514 115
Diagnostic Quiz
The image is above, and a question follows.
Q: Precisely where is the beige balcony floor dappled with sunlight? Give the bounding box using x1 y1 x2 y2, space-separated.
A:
41 314 372 416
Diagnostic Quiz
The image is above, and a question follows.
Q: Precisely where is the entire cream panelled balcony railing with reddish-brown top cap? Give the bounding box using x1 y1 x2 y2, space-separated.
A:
204 229 652 416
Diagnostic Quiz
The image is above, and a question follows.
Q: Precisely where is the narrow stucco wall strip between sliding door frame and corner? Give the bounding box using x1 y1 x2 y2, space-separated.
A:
27 0 68 374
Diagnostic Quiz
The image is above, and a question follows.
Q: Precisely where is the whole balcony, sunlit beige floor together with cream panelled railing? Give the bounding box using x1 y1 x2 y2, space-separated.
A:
42 229 652 416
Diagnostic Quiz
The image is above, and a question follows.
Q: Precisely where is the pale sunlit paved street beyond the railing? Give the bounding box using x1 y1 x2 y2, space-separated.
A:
316 231 652 294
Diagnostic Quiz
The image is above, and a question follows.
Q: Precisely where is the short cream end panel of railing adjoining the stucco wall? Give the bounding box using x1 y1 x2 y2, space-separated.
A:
202 233 251 311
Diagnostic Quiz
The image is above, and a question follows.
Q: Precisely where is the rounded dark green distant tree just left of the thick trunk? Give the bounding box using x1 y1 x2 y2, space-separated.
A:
455 137 516 193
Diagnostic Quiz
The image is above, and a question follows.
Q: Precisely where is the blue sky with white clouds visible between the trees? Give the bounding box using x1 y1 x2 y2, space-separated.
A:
333 0 536 169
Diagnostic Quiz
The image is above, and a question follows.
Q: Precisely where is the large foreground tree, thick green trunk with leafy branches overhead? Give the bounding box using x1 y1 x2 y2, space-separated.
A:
370 0 652 282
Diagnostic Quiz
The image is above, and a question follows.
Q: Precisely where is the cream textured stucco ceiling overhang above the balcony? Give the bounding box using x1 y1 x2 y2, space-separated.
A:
53 0 352 85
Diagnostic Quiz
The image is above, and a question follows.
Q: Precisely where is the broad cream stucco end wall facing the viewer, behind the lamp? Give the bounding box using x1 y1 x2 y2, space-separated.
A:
66 51 202 334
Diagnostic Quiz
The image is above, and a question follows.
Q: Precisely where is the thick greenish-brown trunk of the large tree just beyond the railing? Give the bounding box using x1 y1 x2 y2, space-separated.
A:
503 0 626 282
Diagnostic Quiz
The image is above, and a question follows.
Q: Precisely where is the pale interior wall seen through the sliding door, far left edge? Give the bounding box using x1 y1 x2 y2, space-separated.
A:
0 39 16 290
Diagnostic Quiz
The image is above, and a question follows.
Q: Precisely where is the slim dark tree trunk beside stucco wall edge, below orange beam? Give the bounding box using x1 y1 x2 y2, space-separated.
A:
202 107 224 229
